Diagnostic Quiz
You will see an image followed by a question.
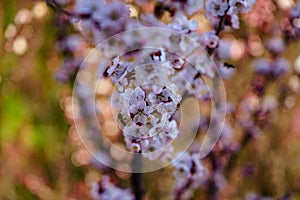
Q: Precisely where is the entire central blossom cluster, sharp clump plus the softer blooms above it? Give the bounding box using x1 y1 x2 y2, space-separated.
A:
105 44 213 160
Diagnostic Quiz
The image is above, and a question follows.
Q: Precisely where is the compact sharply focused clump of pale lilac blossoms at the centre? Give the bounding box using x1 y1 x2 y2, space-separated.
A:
108 66 181 159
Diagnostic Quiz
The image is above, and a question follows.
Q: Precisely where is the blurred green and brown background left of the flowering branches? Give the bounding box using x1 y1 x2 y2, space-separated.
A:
0 0 89 200
